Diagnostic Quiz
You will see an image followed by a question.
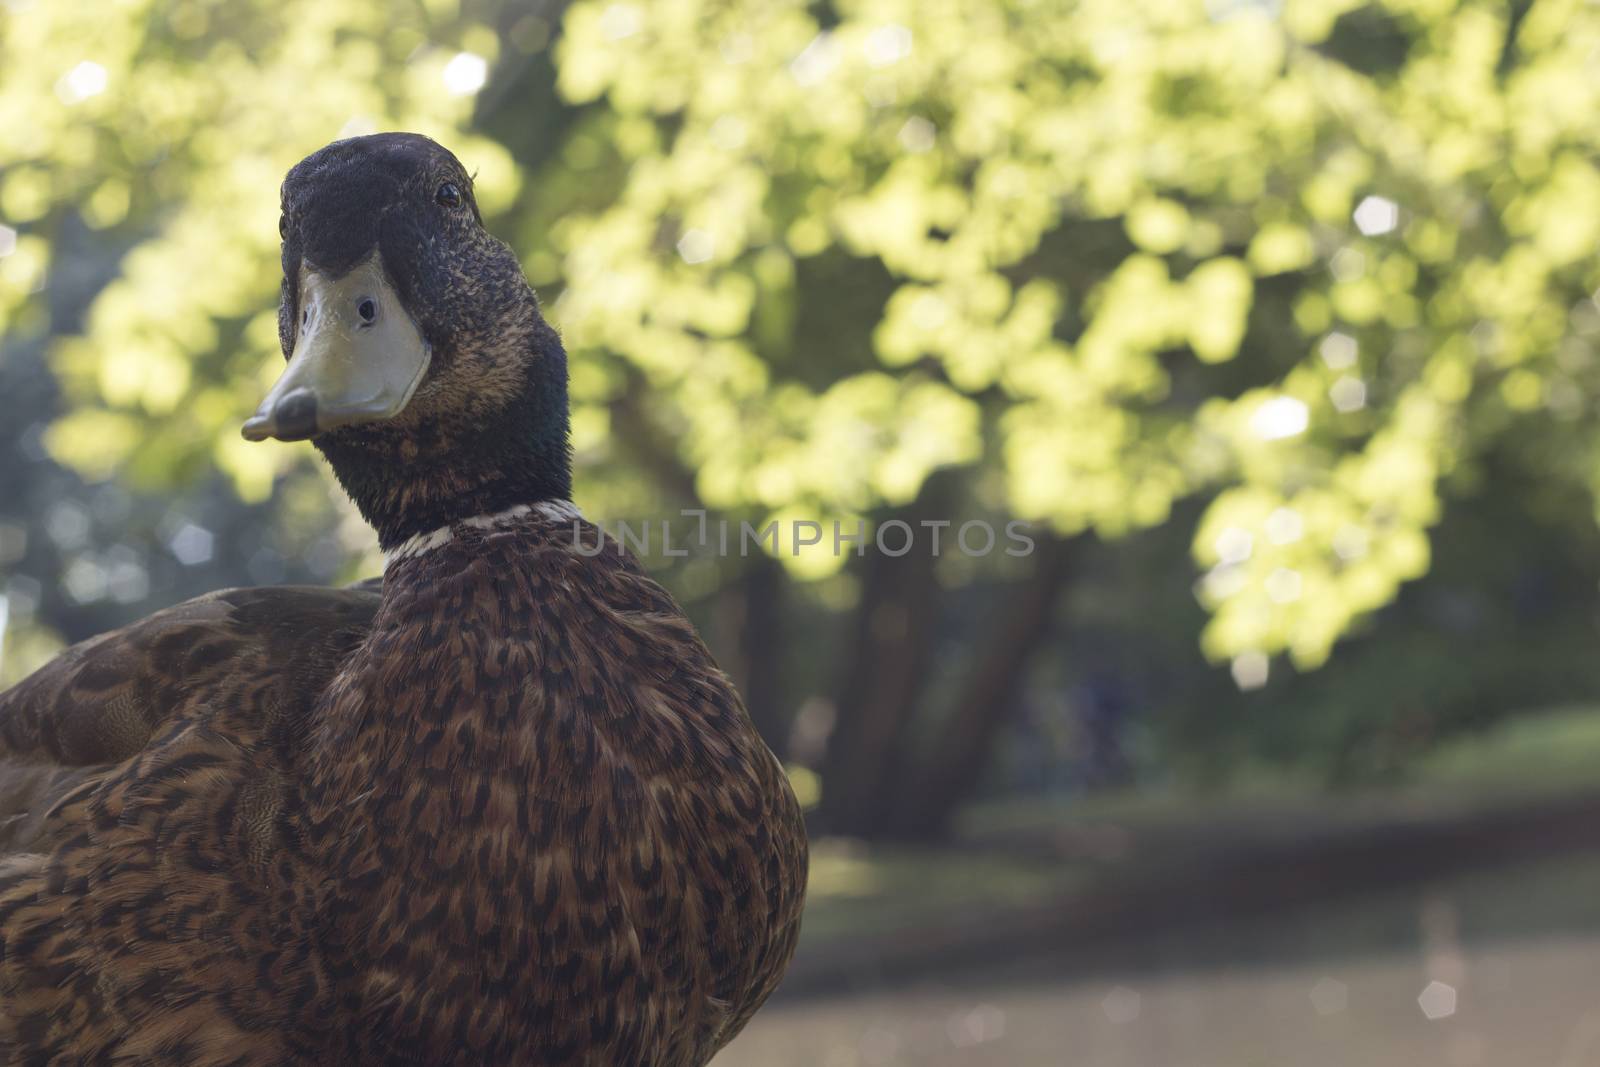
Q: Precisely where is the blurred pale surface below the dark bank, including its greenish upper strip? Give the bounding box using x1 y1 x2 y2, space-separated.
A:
715 857 1600 1067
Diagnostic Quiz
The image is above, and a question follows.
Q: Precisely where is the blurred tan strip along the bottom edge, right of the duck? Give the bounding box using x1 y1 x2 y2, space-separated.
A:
715 936 1600 1067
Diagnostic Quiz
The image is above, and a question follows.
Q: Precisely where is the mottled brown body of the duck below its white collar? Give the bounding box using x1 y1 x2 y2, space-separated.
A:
0 517 805 1067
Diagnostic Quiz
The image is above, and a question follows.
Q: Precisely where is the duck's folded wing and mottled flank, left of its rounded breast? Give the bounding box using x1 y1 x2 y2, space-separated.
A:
0 587 379 1065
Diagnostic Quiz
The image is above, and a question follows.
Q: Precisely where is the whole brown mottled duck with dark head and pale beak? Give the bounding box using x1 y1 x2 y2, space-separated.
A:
0 133 806 1067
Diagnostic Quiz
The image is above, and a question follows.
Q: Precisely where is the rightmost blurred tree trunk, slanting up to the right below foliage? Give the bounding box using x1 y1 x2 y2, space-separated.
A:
890 537 1070 838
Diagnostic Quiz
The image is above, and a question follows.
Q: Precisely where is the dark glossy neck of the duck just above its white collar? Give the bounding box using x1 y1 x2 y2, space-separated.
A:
317 363 573 552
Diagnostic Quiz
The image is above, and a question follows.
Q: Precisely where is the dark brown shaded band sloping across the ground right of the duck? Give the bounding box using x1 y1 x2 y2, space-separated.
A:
784 793 1600 997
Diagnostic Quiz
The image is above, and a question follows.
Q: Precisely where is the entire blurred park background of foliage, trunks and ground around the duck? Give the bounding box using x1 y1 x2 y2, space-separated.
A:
0 0 1600 1067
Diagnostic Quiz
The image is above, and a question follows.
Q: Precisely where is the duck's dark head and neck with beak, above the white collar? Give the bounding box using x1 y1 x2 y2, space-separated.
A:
243 133 571 547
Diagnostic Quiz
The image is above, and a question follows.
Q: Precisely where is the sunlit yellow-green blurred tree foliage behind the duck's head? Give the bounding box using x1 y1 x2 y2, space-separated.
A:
0 0 1600 686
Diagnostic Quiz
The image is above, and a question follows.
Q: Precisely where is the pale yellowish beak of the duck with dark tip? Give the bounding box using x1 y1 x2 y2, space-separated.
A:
243 251 430 442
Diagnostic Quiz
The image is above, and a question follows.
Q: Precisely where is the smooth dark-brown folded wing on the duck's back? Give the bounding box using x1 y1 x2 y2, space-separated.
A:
0 585 378 865
